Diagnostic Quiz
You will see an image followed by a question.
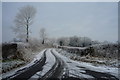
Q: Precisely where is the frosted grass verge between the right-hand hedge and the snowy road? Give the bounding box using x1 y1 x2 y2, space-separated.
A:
57 49 120 67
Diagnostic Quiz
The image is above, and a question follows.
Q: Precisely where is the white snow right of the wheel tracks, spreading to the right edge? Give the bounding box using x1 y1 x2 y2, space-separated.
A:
53 49 119 78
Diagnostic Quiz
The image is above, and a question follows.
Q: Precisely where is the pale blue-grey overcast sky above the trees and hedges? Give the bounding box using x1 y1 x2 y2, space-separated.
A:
2 2 118 42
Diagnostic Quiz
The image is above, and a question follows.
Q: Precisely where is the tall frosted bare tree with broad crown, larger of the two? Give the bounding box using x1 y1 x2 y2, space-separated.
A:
13 5 36 42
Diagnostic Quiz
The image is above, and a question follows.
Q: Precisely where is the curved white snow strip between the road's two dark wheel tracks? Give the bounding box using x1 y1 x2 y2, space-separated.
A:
29 49 56 80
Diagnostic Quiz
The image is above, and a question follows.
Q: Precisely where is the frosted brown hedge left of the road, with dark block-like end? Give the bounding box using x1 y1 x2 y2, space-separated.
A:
2 41 46 62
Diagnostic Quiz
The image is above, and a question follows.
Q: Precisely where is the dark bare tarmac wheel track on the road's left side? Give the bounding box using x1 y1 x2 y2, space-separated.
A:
2 50 47 80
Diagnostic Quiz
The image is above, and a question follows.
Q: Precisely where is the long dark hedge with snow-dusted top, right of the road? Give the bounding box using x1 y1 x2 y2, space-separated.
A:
59 44 118 59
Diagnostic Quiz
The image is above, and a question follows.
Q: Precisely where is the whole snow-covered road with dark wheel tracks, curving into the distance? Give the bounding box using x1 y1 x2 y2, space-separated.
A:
2 48 119 80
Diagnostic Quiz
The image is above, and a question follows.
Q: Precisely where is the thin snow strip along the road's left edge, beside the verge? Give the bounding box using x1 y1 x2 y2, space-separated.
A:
2 50 45 78
